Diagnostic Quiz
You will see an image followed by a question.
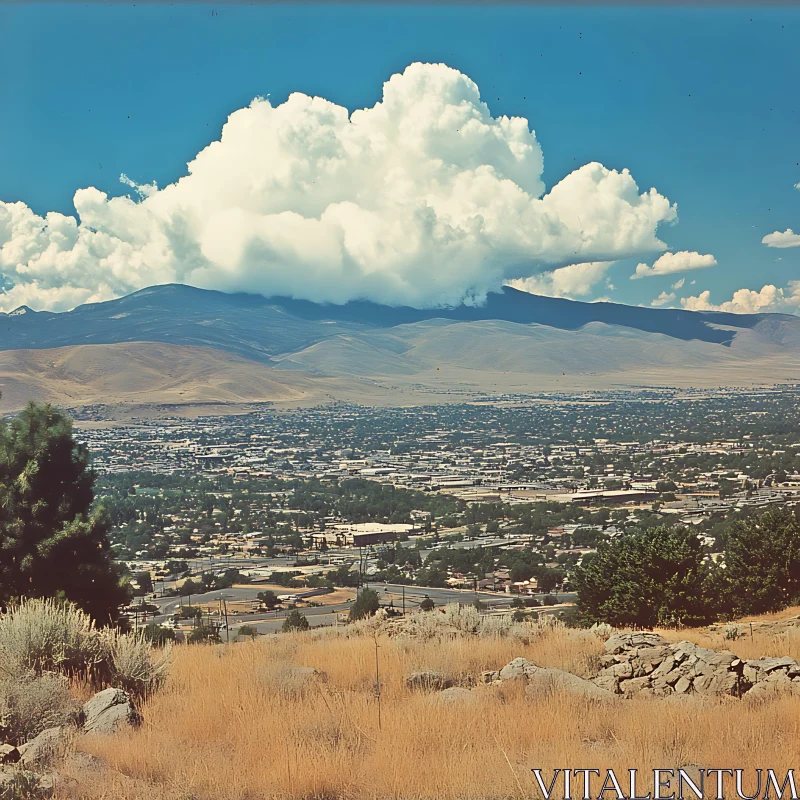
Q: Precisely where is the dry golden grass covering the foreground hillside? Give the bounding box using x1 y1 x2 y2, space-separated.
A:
61 628 800 800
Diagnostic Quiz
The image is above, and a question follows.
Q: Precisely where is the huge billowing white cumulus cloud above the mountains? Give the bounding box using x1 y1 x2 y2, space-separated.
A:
0 64 677 310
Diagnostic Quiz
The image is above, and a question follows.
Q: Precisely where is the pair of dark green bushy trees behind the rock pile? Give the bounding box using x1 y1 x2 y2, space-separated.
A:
572 507 800 628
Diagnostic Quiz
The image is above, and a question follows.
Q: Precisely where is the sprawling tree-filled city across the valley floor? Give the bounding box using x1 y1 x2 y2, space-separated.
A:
76 386 800 637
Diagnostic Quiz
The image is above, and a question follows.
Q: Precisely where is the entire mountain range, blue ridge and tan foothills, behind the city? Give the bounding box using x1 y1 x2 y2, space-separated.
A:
0 284 800 410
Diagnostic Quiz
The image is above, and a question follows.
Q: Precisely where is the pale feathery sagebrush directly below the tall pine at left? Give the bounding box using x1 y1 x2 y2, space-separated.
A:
0 599 102 678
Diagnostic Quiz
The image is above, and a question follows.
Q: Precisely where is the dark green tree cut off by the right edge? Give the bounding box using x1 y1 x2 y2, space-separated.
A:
723 508 800 616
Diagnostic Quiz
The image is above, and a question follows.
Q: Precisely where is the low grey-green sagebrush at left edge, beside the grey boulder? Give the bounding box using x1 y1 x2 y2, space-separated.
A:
0 672 80 745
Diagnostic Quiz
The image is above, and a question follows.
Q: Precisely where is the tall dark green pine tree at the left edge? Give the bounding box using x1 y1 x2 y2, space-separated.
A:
0 403 130 624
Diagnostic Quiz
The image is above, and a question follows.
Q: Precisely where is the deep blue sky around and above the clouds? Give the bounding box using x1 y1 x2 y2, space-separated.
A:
0 3 800 310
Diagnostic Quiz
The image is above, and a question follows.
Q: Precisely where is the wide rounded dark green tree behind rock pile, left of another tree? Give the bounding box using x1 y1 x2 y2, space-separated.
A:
572 526 716 628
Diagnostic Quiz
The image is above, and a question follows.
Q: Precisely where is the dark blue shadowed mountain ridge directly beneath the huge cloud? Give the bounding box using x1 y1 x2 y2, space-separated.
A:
0 284 800 362
